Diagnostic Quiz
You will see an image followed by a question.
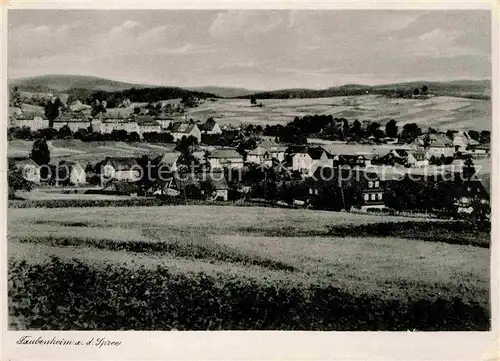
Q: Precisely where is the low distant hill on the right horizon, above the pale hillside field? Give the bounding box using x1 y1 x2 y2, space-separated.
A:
237 80 491 99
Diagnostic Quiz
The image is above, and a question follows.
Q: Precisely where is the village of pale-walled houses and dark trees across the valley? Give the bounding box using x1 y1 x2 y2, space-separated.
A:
9 93 490 217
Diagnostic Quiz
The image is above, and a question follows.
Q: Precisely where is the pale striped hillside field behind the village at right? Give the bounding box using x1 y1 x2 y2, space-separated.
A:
186 95 491 131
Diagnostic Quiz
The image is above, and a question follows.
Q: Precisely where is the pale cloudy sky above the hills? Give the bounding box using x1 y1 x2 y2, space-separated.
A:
8 10 491 90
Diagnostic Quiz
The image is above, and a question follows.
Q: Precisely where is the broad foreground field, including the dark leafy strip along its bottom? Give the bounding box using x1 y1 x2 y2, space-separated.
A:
8 206 489 330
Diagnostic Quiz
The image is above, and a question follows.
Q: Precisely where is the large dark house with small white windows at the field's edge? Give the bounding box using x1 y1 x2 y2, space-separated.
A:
308 166 385 210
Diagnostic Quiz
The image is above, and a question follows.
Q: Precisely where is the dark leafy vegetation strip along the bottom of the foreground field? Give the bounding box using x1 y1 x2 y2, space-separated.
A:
9 258 490 331
